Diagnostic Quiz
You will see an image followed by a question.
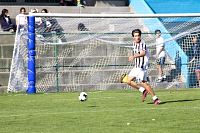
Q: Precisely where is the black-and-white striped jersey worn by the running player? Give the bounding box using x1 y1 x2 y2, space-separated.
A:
133 40 149 69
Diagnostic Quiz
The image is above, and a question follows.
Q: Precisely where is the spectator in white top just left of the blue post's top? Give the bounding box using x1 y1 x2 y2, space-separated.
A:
16 7 27 29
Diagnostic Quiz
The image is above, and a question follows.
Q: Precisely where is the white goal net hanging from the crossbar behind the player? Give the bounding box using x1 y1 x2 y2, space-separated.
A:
8 13 200 92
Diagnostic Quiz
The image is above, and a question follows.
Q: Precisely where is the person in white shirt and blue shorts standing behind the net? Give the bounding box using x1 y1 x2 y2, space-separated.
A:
155 30 166 82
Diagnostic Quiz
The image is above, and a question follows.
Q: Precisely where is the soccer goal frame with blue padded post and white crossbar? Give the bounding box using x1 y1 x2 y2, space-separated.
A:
10 13 200 94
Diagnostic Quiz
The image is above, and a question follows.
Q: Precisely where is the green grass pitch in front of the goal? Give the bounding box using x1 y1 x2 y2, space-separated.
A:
0 89 200 133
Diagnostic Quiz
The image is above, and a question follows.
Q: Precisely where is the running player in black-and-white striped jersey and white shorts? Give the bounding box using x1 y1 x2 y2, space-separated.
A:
122 29 160 105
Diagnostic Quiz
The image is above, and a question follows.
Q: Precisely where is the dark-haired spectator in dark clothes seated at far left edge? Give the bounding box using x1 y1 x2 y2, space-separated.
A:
0 9 16 32
